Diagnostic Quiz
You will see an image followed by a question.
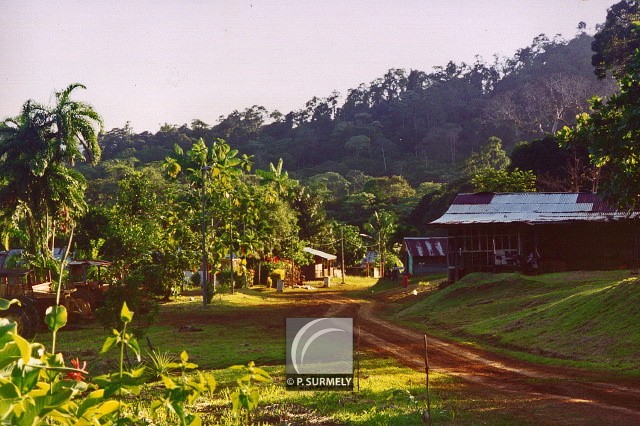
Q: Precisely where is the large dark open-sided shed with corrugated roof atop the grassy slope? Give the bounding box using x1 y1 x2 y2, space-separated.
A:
431 192 640 279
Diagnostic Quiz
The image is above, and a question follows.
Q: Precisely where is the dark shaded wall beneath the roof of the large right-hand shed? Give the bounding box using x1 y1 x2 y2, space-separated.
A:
448 222 640 280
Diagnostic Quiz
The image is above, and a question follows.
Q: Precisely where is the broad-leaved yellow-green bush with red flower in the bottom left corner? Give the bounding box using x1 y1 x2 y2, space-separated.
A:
0 299 121 425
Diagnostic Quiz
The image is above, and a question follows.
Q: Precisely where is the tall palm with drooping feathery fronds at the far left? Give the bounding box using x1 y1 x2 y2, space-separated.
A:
0 84 102 272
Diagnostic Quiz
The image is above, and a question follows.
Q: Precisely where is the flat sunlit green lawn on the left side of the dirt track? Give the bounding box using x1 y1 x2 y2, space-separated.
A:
46 277 476 425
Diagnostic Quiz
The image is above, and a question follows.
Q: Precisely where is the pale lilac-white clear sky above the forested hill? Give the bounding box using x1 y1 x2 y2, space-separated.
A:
0 0 617 132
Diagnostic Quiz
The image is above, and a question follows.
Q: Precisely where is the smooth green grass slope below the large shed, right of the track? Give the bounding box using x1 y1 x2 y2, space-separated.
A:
395 271 640 375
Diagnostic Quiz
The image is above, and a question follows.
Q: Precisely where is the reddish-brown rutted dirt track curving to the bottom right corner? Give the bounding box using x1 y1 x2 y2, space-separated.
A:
315 294 640 424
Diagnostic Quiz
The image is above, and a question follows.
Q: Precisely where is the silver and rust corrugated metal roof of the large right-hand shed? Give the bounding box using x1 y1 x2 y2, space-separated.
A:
431 192 640 225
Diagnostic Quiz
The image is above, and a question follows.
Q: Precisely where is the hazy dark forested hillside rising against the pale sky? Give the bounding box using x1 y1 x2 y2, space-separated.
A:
96 33 614 181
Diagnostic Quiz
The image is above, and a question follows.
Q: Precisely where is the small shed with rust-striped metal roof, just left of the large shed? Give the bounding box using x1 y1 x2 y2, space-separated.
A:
403 237 449 275
